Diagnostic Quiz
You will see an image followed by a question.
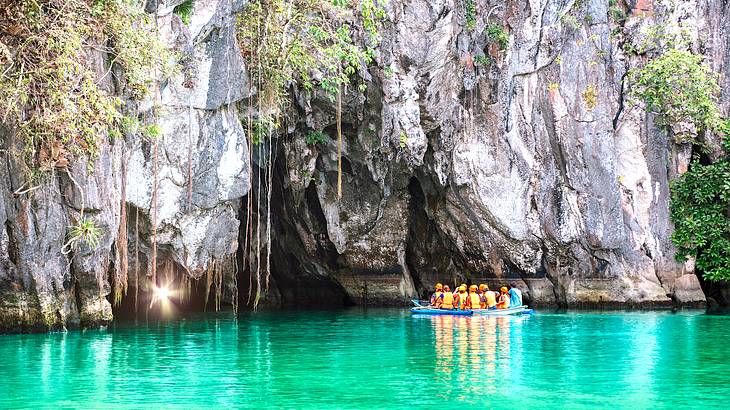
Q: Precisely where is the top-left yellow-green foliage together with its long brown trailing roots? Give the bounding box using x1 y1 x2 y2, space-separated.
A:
0 0 176 305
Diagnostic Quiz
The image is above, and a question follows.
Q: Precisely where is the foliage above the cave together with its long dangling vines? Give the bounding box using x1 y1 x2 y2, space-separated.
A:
237 0 385 308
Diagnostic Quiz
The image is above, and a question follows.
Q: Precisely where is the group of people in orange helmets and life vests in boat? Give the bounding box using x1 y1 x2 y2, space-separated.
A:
430 283 522 310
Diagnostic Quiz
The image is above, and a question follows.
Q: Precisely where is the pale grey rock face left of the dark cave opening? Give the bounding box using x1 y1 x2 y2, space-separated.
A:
0 0 250 330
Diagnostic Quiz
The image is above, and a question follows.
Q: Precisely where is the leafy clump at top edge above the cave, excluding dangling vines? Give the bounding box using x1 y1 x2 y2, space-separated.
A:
237 0 385 116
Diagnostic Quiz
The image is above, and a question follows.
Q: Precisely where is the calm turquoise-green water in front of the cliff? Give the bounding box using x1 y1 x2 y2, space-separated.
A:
0 309 730 409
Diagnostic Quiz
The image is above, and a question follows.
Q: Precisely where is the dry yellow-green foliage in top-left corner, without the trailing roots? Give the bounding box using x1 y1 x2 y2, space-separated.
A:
0 0 170 173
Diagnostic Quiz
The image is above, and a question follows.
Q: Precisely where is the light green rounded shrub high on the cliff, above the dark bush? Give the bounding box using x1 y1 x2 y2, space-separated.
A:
628 49 722 139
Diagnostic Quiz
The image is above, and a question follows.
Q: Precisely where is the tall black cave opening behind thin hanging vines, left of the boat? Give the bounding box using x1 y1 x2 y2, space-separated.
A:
236 139 354 310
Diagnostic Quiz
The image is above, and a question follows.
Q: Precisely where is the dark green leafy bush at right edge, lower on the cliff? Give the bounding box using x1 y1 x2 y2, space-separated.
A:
670 145 730 280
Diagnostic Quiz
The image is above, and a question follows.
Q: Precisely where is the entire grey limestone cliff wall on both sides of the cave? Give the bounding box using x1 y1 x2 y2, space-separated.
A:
0 0 730 330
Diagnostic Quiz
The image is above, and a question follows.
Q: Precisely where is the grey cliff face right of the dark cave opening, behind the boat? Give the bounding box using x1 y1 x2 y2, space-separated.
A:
264 1 728 306
